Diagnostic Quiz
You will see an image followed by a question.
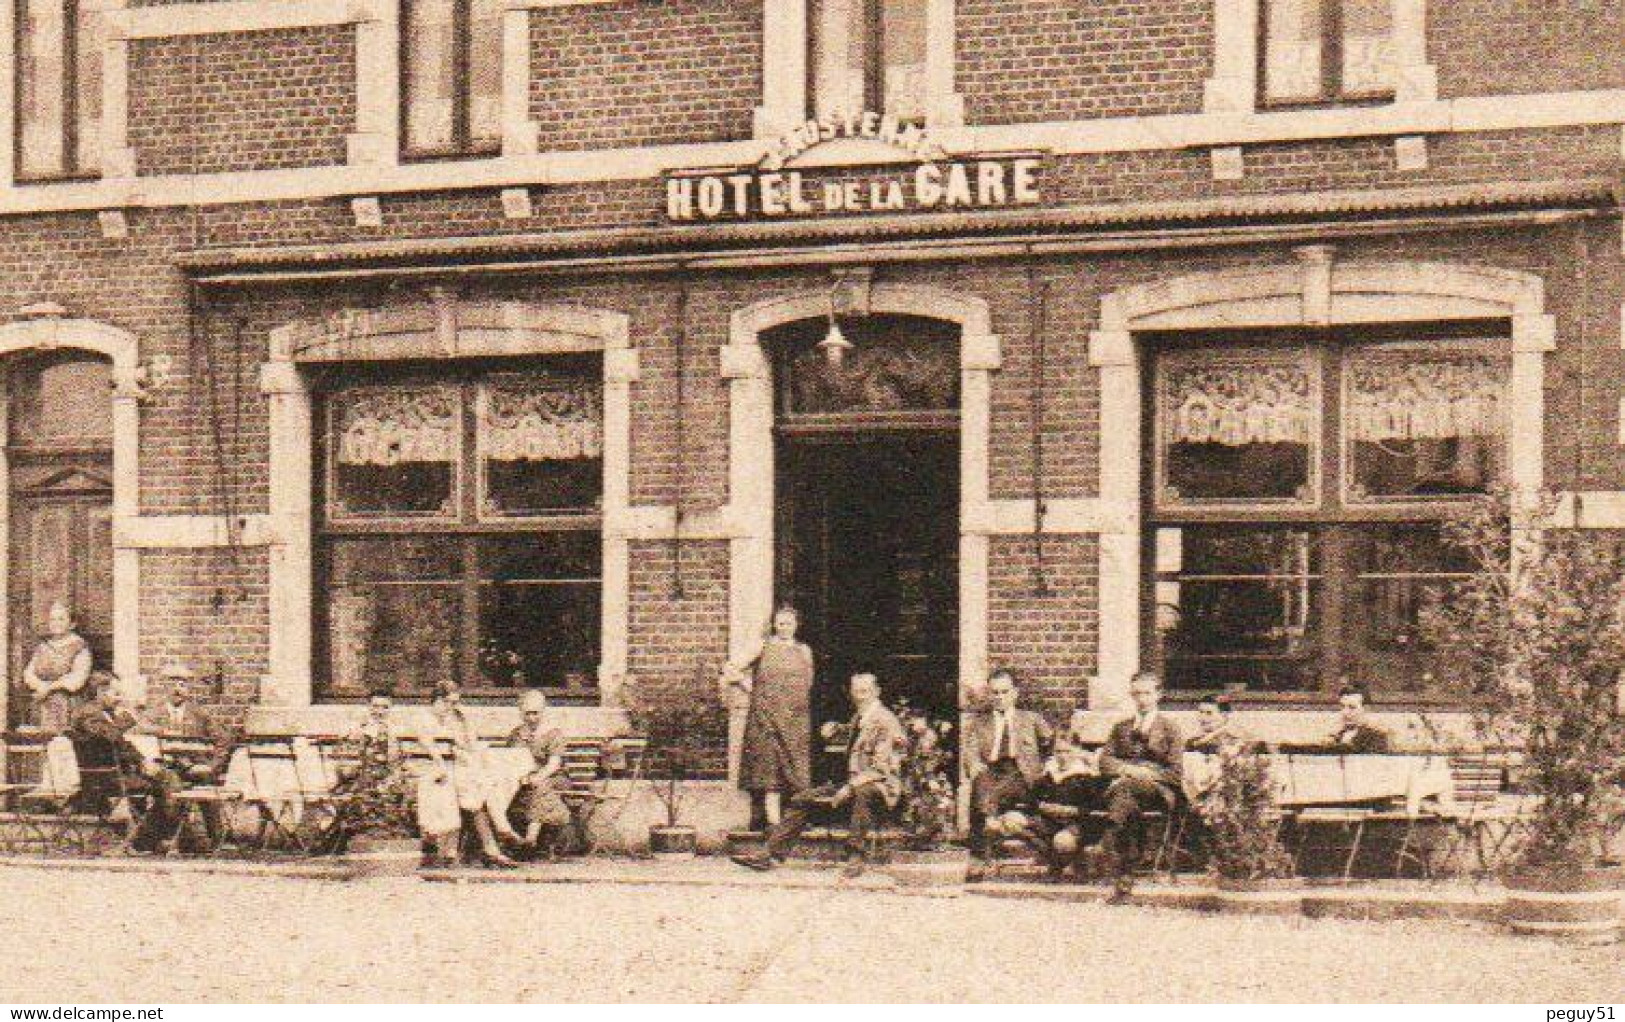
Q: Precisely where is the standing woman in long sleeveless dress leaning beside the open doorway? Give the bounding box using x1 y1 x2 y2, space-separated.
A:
733 606 813 827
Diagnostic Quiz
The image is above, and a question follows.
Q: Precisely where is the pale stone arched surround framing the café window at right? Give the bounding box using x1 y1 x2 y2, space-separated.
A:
1089 245 1557 710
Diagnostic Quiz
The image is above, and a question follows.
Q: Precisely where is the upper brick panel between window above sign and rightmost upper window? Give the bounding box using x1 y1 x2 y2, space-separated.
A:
956 0 1212 123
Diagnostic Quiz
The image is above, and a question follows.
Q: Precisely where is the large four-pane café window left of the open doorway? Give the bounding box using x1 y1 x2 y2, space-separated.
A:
317 356 603 699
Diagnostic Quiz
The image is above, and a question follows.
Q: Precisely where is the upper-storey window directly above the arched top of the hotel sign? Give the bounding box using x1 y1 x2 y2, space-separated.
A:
809 0 926 122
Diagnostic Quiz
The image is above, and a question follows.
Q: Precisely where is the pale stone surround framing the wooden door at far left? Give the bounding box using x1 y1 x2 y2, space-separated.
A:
0 305 143 715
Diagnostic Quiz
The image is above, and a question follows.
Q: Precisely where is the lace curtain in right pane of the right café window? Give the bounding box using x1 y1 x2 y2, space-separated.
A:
1344 356 1506 442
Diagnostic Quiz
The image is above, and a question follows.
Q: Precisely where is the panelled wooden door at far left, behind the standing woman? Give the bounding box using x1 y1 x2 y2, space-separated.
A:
3 351 114 726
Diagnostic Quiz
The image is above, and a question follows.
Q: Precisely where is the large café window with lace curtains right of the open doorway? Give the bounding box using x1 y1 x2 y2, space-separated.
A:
1146 333 1510 704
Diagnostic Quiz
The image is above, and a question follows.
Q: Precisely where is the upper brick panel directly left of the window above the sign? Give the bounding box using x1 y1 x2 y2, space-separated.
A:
530 0 762 149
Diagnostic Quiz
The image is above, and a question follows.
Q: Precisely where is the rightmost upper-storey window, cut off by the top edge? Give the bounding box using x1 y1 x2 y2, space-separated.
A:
1259 0 1396 104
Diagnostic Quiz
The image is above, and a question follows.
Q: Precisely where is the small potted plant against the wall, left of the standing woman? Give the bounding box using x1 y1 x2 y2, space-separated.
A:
622 671 722 858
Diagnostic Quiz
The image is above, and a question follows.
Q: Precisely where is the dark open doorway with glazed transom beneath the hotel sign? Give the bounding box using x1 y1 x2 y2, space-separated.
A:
772 317 960 770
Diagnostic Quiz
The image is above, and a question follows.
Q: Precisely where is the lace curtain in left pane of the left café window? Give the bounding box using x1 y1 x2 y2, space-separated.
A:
338 388 458 466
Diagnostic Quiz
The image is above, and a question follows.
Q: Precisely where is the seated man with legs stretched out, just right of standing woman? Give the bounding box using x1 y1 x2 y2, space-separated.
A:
733 674 907 877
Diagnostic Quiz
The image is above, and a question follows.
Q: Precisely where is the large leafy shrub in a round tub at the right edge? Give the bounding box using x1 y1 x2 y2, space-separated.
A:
1424 496 1625 941
